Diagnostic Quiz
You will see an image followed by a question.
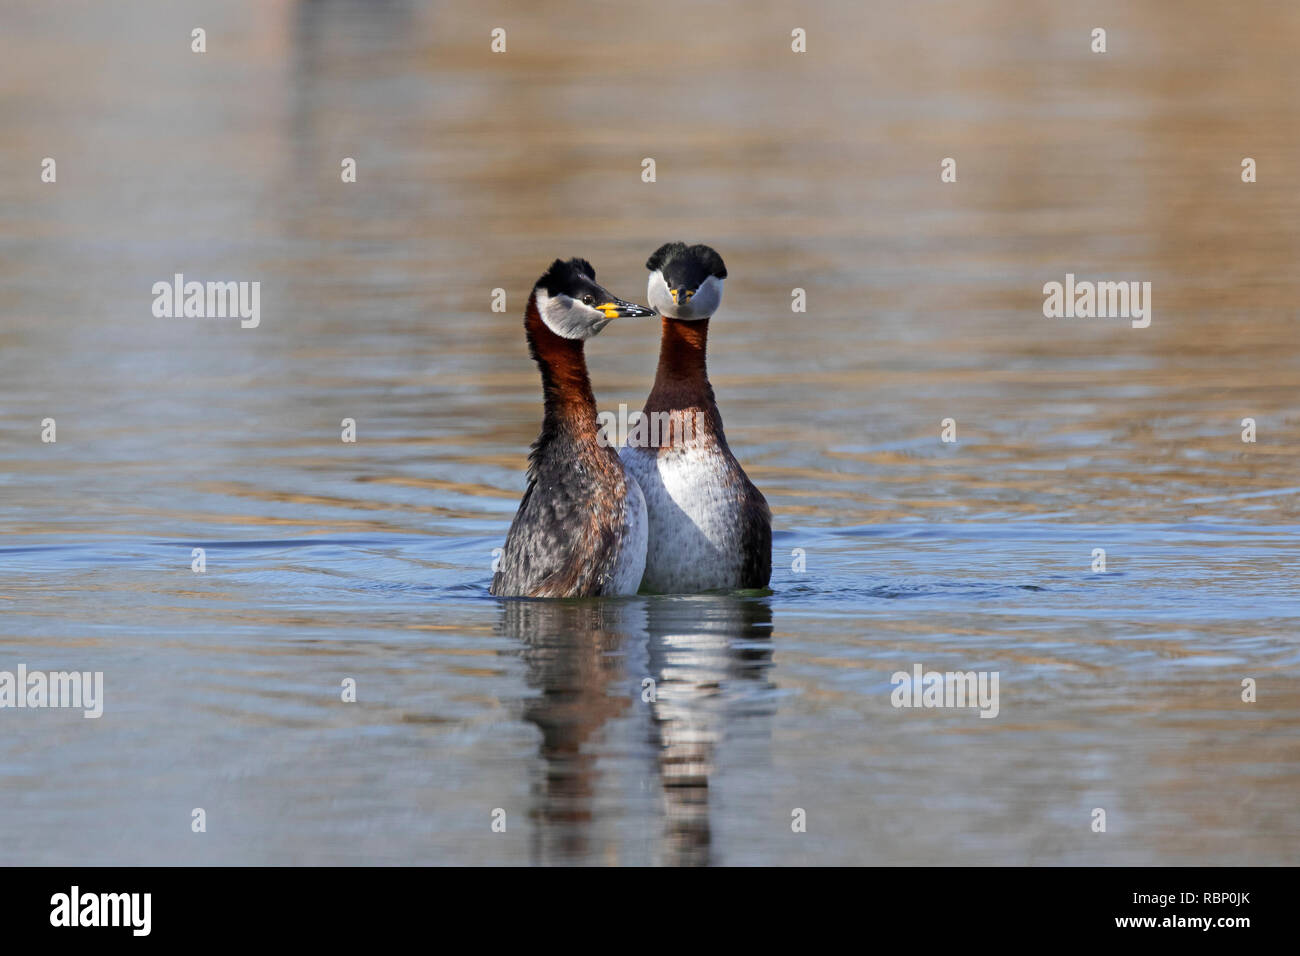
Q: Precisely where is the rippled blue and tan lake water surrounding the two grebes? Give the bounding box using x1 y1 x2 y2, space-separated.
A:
0 0 1300 865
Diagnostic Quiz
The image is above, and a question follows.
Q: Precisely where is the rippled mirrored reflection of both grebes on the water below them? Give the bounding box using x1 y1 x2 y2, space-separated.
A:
499 596 775 865
